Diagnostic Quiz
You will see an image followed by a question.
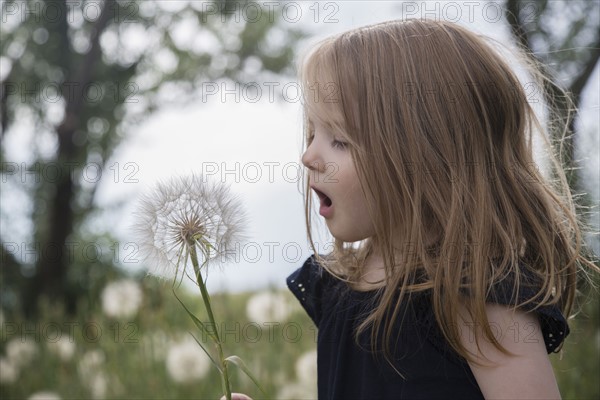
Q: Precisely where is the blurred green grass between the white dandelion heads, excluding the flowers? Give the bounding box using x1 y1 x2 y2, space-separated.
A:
0 278 600 399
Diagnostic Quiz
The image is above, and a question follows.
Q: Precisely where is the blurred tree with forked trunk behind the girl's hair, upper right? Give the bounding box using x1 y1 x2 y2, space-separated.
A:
506 0 600 192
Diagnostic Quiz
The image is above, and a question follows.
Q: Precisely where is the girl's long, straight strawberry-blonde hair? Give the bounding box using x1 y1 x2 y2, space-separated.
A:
299 20 597 366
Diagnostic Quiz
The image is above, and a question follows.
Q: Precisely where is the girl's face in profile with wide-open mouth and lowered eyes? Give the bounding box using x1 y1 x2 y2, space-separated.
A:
302 122 375 242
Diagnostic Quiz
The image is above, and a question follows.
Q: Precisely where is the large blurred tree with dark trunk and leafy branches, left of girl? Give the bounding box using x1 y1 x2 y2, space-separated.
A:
0 0 303 315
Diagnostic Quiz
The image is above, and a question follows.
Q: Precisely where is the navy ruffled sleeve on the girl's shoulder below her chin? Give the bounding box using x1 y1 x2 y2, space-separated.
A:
287 255 323 327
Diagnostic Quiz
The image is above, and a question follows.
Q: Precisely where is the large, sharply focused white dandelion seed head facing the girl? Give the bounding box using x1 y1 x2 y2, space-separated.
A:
134 175 246 279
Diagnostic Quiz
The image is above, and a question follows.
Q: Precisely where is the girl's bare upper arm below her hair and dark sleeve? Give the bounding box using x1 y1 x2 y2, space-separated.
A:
460 303 560 399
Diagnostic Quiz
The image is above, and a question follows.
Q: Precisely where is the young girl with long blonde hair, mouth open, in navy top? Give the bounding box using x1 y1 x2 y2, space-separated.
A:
236 20 596 399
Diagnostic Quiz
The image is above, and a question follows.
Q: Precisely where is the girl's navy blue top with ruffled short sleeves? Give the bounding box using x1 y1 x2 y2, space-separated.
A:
287 256 569 400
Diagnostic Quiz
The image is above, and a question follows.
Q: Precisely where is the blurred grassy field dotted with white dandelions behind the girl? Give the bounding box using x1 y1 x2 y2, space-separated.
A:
0 278 600 399
